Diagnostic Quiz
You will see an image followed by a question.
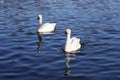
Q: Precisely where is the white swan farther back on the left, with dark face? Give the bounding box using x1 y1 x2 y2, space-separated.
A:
38 15 56 33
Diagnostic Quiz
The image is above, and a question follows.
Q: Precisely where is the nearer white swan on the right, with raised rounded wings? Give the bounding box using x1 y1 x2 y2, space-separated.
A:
64 29 81 52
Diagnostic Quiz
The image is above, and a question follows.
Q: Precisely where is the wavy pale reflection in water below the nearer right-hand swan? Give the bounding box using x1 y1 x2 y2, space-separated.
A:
64 53 76 76
